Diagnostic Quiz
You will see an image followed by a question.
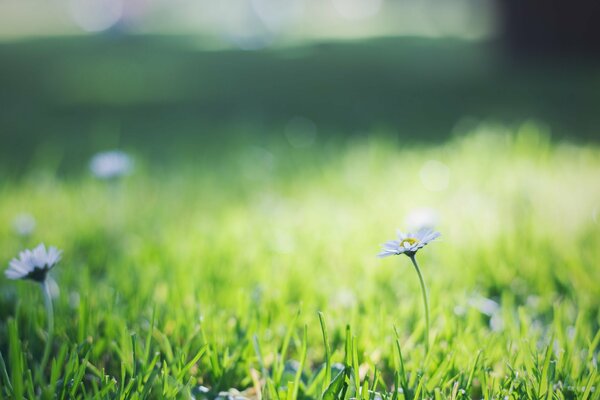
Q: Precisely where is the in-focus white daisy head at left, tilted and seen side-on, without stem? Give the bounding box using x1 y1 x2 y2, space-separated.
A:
4 243 62 282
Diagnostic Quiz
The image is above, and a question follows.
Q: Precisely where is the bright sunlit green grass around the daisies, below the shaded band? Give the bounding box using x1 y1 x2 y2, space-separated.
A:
0 124 600 400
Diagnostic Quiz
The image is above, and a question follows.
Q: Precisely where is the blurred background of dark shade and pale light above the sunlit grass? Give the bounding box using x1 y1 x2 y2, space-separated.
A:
0 0 600 175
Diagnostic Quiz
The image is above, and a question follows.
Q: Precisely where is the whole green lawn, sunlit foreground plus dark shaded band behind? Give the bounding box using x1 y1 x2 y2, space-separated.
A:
0 35 600 400
